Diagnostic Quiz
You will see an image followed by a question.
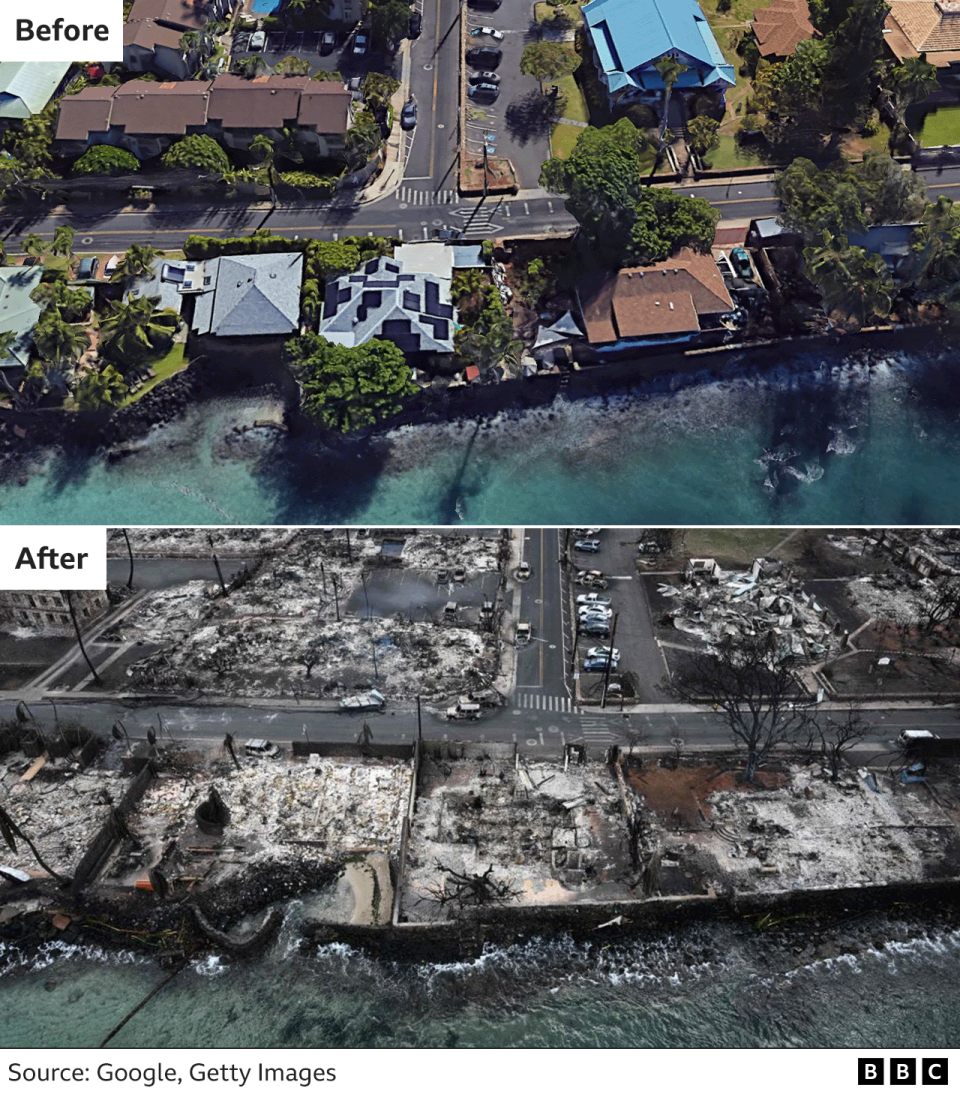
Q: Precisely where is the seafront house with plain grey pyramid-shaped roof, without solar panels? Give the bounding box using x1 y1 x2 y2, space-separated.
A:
190 252 303 338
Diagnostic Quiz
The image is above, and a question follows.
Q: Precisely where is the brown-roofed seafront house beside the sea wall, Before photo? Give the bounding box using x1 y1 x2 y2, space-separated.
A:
577 248 734 346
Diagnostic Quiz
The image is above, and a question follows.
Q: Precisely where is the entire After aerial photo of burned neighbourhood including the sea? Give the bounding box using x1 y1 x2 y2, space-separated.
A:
0 527 960 1047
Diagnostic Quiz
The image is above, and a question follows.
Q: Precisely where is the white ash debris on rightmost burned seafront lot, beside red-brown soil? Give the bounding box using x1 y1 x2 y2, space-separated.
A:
696 767 960 892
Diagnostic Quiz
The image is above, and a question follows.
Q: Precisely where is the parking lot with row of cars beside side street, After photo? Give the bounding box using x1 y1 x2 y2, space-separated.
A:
569 528 667 702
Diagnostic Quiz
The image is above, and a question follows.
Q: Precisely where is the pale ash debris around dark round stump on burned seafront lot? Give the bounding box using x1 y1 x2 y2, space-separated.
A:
128 756 412 862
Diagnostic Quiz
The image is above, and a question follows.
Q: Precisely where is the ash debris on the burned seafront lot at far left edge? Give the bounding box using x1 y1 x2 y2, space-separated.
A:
0 754 129 875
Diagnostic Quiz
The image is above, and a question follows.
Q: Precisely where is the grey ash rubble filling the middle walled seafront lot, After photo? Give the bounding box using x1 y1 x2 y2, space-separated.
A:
403 759 630 920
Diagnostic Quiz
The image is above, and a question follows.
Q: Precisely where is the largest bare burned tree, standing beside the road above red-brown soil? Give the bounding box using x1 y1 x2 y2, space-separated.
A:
670 636 809 782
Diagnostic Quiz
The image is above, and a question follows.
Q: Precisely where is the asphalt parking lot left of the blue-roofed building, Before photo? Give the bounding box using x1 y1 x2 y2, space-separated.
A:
464 4 550 188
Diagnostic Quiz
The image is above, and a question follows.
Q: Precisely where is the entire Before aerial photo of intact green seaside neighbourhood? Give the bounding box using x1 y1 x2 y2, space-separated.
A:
0 0 960 524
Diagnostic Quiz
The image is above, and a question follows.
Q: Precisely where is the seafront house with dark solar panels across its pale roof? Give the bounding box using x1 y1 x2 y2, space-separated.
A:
319 258 454 353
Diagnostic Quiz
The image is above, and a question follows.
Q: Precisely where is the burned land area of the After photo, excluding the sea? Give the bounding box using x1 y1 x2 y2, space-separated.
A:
0 527 960 964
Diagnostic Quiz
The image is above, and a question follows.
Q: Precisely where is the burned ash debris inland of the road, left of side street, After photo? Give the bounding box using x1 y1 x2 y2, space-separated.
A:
121 532 507 698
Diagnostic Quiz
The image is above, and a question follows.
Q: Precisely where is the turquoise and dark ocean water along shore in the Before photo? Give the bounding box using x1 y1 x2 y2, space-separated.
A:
0 343 960 525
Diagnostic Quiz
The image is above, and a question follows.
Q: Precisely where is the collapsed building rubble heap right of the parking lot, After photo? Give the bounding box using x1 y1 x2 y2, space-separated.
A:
657 558 842 662
